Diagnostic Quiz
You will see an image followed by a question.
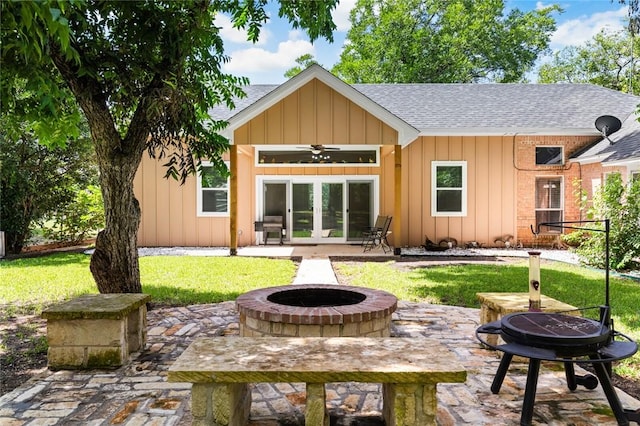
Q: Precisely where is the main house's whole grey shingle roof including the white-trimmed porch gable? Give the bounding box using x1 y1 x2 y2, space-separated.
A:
211 65 640 139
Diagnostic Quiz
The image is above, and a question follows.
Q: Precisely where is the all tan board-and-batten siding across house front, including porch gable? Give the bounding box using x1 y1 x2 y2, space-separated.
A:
135 80 516 247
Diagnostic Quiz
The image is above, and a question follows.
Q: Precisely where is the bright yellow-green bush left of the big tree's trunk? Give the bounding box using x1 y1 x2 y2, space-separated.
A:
43 185 104 243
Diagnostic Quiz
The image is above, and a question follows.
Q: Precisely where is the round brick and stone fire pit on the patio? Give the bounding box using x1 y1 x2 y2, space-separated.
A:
236 284 398 337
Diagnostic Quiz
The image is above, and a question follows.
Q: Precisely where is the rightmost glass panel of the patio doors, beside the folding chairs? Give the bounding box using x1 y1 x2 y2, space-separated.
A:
347 181 374 241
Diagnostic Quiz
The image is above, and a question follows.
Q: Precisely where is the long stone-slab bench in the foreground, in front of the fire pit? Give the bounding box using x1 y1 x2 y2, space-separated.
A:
168 337 467 426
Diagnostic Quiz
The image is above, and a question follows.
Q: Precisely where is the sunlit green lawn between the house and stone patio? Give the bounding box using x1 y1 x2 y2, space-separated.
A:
0 254 640 379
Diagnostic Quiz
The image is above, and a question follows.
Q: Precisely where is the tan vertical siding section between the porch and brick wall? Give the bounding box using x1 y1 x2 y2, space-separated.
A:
402 136 516 246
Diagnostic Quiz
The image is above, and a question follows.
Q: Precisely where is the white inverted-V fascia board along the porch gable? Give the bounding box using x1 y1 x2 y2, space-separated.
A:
221 64 419 146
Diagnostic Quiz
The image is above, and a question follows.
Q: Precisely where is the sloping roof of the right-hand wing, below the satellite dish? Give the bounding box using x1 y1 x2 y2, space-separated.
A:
572 114 640 166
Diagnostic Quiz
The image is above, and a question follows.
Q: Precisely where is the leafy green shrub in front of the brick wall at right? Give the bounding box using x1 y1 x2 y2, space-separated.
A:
576 173 640 271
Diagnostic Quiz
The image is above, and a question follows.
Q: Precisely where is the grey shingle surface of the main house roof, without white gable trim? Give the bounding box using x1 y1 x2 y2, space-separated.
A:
211 80 640 133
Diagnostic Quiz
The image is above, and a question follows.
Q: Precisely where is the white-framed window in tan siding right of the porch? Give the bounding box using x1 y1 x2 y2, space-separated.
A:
431 161 467 216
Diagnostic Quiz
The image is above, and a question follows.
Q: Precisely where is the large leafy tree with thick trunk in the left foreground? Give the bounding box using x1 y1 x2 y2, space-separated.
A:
0 0 336 293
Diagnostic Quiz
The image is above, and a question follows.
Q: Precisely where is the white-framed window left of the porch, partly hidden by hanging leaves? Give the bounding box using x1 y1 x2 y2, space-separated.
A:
198 162 229 216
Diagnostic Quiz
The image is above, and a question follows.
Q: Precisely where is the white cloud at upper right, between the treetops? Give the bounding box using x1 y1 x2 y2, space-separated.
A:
551 6 627 50
